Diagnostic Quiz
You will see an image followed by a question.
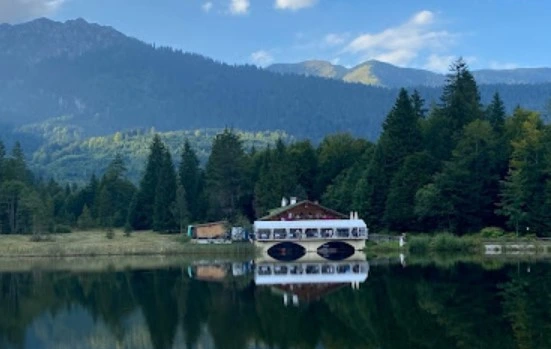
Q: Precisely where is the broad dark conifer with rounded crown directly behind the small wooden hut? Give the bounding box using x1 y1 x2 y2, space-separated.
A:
205 129 246 220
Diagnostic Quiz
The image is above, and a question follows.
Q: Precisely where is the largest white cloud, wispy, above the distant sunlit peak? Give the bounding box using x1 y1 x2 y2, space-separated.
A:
343 10 455 66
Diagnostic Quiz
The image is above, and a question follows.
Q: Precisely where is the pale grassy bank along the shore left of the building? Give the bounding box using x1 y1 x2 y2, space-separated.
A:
0 231 254 257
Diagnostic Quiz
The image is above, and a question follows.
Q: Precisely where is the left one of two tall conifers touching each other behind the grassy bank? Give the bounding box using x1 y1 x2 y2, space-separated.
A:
132 134 166 230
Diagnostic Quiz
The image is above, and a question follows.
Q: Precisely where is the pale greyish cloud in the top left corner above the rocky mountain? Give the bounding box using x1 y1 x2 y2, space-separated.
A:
0 0 66 23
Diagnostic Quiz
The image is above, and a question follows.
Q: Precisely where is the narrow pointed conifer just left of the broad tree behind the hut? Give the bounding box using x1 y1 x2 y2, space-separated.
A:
178 140 204 222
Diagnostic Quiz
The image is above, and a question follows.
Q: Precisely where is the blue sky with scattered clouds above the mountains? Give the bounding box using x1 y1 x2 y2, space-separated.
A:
0 0 551 71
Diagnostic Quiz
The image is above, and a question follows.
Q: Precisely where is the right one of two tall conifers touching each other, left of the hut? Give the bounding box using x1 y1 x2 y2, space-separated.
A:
152 149 176 232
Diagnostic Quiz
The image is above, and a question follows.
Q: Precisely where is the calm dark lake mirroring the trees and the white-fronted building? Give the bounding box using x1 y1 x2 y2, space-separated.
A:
0 253 551 349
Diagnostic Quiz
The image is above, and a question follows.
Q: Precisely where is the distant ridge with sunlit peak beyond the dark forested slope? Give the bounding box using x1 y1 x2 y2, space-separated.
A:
266 60 551 87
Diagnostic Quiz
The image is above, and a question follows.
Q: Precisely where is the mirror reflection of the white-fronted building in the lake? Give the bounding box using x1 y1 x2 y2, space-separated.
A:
254 260 369 305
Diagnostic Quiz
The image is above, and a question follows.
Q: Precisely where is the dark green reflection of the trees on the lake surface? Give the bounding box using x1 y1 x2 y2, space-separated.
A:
0 264 551 349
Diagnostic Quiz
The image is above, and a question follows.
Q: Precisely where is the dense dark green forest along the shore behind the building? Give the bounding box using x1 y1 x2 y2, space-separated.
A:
0 60 551 235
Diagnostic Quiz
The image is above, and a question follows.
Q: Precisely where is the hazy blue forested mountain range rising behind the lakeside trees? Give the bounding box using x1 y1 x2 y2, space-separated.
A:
0 19 551 150
